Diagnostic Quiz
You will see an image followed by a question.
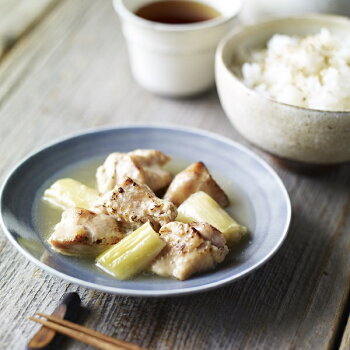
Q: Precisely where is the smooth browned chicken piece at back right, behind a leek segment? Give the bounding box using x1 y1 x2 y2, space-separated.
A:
164 162 229 207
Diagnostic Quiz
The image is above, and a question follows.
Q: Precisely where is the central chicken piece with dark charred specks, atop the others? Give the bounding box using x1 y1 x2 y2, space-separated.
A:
94 178 177 230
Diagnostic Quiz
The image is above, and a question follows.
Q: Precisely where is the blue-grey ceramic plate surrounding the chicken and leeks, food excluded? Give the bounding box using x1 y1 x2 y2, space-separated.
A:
0 126 291 296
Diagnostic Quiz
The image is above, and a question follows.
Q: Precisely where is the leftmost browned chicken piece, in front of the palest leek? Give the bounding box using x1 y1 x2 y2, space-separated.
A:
49 208 125 256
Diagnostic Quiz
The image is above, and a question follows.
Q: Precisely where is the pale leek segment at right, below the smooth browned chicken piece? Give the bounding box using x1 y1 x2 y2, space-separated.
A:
176 191 248 245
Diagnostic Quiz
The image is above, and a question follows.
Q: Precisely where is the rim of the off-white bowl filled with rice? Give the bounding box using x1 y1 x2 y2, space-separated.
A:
215 14 350 117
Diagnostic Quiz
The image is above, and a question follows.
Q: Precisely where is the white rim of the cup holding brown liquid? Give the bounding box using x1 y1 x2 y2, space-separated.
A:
112 0 244 33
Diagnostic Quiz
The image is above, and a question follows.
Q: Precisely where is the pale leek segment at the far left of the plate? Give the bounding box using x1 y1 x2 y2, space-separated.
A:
43 178 98 210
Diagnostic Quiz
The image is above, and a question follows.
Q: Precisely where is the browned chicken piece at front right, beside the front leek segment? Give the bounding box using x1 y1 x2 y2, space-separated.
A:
151 221 228 280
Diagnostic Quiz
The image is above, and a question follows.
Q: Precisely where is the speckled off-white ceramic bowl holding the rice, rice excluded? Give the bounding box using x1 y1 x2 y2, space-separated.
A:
216 15 350 164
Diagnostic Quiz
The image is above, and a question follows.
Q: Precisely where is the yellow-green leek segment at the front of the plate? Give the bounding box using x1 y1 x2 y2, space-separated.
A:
97 222 165 280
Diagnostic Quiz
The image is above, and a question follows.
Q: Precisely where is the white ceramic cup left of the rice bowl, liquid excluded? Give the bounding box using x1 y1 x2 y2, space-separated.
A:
114 0 242 97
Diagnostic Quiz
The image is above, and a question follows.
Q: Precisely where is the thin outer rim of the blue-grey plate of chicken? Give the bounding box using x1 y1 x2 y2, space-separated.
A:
0 123 292 297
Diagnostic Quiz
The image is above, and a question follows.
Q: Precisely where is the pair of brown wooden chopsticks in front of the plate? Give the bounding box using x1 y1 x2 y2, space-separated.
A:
29 312 145 350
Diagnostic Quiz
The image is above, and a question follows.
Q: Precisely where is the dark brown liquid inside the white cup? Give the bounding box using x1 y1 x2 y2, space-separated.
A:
135 0 221 24
